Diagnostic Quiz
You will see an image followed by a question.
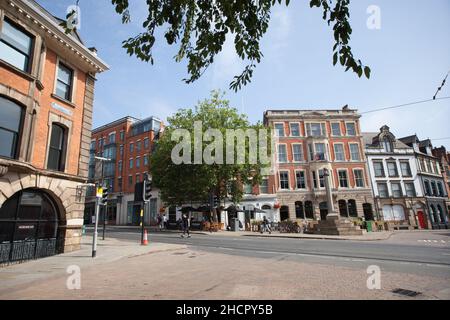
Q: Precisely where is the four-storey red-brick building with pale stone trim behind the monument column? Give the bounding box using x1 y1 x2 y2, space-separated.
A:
264 106 373 220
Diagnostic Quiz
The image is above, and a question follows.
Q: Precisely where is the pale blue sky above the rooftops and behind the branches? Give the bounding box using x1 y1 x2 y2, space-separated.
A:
38 0 450 149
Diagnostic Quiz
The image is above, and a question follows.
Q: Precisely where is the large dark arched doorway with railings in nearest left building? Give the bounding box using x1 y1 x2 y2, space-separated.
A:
0 189 64 263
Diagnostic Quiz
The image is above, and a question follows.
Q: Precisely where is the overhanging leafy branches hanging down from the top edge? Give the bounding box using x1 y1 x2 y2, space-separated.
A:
63 0 370 90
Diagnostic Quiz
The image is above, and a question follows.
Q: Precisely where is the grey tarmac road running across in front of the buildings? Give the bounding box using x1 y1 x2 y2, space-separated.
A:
88 226 450 279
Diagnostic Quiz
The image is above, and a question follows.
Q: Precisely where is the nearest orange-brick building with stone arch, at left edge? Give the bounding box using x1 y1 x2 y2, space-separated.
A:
0 0 108 263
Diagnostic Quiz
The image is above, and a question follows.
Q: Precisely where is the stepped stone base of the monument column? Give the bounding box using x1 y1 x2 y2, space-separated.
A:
312 212 363 236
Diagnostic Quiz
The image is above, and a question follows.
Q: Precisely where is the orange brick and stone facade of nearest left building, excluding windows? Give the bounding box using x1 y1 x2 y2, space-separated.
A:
0 0 108 262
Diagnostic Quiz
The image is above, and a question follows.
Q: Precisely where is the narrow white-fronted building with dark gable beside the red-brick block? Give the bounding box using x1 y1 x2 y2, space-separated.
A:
363 125 431 229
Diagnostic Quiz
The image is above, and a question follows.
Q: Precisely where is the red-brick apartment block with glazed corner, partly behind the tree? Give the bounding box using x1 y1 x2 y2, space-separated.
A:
85 117 163 225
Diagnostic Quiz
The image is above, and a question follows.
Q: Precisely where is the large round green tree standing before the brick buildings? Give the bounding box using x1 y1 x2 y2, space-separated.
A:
149 91 271 218
